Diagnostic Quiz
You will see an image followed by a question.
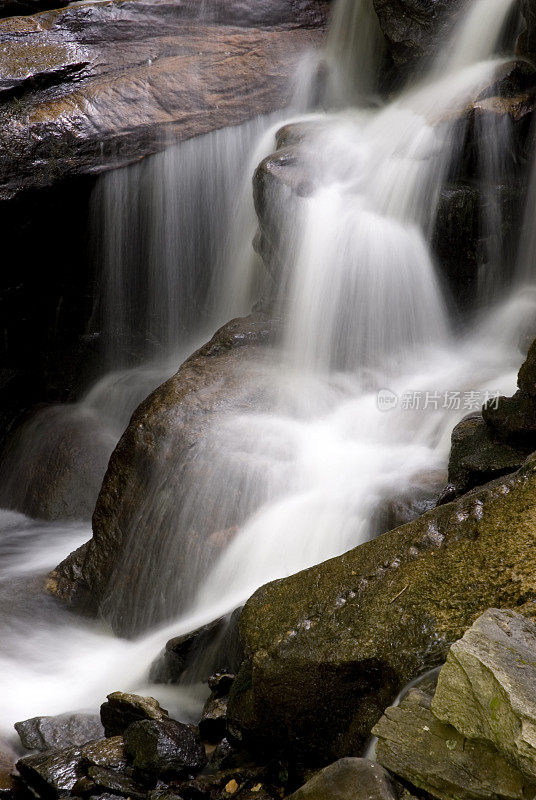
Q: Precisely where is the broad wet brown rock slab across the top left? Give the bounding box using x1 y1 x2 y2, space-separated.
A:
0 0 327 198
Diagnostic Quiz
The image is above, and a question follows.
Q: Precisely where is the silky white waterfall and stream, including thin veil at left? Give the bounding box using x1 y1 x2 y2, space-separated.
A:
0 0 536 736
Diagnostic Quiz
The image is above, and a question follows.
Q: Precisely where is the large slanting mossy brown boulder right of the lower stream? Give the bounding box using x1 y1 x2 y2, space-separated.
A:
228 457 536 762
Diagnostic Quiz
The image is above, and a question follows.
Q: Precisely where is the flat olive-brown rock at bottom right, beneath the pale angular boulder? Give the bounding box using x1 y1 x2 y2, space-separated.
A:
373 689 536 800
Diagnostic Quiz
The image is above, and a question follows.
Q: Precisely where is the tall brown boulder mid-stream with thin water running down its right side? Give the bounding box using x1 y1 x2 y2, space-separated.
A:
48 314 276 635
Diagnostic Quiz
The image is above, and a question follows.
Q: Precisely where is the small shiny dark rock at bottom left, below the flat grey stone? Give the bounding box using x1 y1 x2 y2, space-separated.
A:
17 747 82 797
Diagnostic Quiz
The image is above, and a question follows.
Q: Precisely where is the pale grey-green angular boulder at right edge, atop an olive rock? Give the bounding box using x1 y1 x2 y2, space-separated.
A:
432 609 536 781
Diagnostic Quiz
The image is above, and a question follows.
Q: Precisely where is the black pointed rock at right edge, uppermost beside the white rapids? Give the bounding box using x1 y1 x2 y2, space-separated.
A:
482 339 536 440
